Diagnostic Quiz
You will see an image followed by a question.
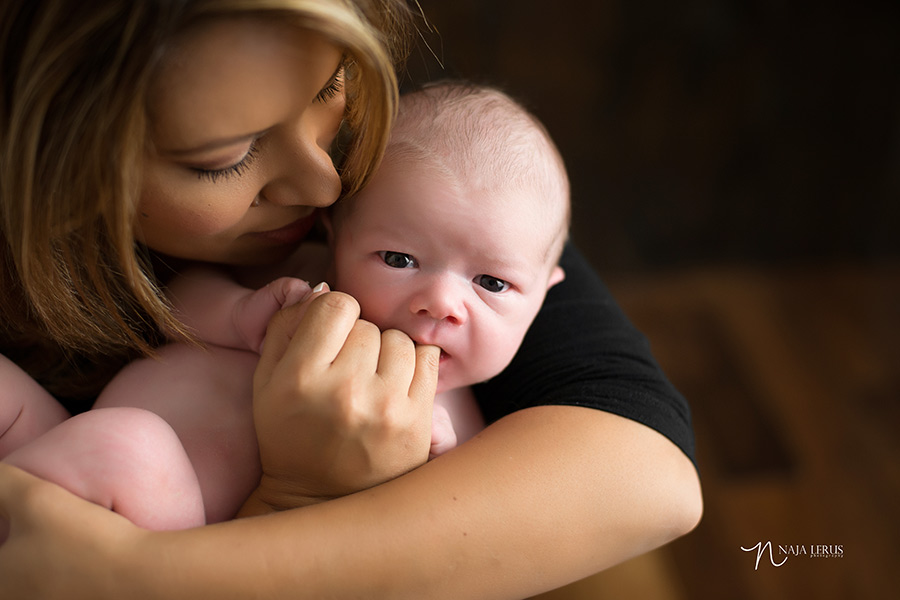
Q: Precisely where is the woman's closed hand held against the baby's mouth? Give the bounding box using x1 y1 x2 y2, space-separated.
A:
241 292 439 516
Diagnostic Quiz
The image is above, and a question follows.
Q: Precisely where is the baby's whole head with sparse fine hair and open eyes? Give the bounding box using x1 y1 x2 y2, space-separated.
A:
332 83 569 391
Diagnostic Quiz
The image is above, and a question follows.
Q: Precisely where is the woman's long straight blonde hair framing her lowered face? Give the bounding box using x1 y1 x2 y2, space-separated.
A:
0 0 410 404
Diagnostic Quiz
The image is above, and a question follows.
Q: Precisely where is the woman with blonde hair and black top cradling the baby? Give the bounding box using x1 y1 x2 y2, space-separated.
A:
0 0 700 598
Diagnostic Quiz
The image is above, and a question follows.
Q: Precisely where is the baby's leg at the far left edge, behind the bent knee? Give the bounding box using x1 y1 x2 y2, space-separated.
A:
0 355 69 459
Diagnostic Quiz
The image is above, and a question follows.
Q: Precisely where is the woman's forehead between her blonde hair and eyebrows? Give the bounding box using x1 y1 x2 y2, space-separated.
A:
148 19 340 149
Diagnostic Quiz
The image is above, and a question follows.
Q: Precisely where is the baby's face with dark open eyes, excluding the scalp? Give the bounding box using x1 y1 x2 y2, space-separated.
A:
334 161 562 392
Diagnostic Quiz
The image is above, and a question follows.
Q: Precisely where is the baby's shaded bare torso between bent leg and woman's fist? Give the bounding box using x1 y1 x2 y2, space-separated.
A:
94 344 260 523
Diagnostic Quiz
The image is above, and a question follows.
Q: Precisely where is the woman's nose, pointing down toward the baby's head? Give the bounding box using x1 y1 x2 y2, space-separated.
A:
260 119 341 206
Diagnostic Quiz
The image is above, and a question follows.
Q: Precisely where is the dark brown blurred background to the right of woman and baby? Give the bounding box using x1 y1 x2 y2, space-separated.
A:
406 0 900 600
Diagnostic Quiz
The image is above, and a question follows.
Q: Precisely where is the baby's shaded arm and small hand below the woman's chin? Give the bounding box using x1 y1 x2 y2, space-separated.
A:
168 268 310 352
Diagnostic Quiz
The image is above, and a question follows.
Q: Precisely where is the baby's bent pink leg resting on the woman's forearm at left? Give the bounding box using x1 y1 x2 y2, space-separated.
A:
4 408 204 530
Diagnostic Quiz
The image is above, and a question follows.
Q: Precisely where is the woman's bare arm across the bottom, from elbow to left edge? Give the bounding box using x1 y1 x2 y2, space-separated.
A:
0 245 702 598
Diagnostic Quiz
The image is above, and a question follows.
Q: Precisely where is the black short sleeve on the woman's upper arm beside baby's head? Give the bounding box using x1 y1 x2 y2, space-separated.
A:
474 244 695 461
